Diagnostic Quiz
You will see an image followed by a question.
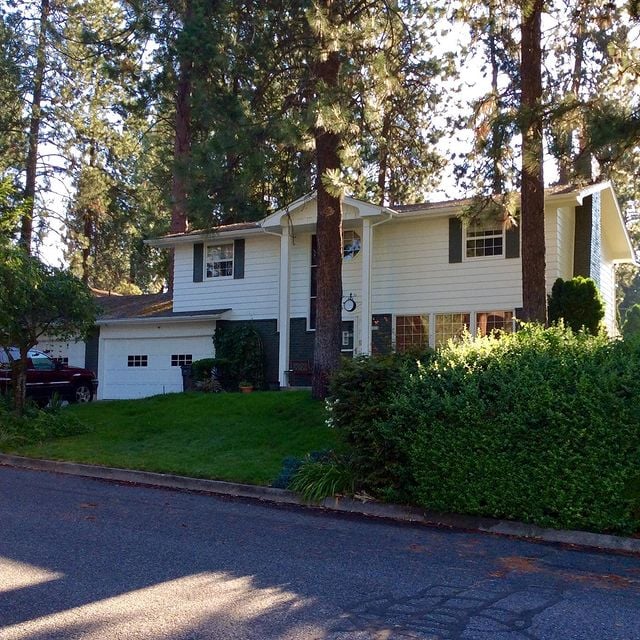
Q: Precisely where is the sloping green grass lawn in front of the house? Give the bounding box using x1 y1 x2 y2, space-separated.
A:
7 391 337 484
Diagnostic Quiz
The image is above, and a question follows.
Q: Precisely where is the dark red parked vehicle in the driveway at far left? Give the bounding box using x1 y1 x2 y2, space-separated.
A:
0 347 98 404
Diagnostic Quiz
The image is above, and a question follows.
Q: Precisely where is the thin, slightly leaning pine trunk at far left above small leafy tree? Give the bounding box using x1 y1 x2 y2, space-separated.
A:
20 0 50 254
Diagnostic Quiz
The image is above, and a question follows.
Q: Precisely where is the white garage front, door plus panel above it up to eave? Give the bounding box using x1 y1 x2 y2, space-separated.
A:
98 321 215 400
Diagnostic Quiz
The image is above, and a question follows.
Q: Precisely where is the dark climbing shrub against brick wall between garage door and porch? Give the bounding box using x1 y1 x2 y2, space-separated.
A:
213 322 264 390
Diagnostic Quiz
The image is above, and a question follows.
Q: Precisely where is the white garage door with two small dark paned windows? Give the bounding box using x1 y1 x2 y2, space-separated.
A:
98 335 213 400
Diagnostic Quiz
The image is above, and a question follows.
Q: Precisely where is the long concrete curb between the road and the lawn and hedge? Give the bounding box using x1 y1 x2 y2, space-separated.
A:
0 454 640 554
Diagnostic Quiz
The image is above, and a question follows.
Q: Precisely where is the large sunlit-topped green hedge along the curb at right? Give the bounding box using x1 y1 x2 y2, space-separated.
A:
385 325 640 533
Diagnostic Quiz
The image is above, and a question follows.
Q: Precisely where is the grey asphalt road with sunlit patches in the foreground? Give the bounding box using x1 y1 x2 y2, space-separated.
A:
0 467 640 640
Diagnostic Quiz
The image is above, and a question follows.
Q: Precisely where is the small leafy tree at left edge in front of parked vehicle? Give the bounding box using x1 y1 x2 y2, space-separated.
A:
0 246 97 415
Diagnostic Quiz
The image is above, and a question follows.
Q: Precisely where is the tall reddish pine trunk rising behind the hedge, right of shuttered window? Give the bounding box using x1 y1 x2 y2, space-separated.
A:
520 0 547 324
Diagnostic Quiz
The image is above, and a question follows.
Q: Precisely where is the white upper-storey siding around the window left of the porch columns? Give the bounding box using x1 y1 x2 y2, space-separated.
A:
173 234 280 320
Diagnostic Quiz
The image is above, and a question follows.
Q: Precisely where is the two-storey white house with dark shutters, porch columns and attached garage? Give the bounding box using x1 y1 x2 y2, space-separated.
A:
40 182 634 398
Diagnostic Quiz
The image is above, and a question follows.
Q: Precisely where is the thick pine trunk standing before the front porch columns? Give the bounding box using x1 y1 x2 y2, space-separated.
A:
312 52 342 398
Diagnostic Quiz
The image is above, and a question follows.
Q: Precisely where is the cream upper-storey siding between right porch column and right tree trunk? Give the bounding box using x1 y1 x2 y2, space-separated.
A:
371 218 522 314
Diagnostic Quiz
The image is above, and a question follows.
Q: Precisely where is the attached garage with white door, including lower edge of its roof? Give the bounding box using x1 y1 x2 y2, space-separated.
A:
98 296 228 400
